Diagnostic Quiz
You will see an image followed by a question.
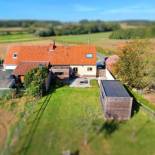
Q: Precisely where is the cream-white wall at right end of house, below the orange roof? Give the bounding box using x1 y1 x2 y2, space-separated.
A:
70 66 96 77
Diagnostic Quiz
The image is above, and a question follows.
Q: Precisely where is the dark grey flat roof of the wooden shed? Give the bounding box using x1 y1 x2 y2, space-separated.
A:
101 80 130 97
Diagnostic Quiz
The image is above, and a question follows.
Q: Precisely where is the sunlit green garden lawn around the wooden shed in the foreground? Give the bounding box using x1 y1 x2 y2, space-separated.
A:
13 81 155 155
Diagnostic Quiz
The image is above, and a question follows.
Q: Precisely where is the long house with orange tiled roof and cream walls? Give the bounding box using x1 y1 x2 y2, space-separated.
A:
3 44 96 79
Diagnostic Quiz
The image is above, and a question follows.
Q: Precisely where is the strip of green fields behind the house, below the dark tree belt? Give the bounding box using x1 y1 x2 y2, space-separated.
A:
0 32 111 44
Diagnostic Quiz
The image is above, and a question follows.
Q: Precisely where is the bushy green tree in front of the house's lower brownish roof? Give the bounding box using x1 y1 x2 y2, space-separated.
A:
24 66 48 96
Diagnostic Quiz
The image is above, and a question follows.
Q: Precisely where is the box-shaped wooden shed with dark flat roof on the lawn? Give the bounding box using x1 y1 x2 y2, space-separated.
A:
100 80 133 120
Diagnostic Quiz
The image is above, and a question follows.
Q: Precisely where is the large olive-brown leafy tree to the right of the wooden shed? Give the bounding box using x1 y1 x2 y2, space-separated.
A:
117 41 148 89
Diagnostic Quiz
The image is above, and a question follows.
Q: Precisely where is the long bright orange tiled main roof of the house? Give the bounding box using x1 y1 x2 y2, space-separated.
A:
4 45 96 65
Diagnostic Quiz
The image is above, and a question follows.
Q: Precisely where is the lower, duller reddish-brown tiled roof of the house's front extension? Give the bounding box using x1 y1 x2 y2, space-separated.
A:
13 62 48 75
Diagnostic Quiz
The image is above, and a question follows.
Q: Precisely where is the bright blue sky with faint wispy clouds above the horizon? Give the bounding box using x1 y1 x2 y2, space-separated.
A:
0 0 155 21
